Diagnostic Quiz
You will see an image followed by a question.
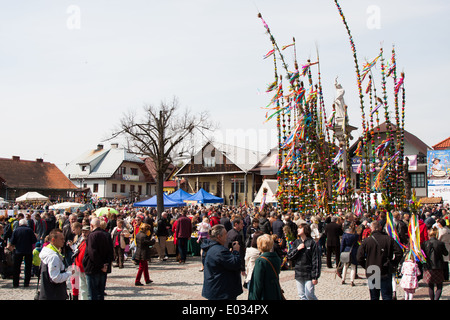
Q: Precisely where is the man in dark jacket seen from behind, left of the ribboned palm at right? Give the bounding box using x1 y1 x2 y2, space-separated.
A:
356 221 403 300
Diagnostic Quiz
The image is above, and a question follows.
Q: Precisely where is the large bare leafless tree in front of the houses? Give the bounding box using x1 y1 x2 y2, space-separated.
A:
108 98 214 218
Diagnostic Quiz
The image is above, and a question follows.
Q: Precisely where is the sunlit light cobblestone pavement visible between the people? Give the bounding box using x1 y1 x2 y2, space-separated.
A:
0 256 450 301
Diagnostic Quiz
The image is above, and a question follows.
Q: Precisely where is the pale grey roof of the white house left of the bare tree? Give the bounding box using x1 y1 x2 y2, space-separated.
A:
63 147 144 179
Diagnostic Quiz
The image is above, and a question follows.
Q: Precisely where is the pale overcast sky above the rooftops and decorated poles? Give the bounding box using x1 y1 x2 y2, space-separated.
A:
0 0 450 167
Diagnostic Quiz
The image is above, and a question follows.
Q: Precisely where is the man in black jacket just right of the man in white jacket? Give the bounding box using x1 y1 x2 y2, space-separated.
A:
83 218 114 300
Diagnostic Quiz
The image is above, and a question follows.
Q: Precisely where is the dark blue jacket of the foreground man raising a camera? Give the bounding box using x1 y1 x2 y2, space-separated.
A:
202 239 243 300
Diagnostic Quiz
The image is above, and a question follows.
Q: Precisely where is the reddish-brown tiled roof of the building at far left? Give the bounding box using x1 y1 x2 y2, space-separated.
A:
0 157 77 190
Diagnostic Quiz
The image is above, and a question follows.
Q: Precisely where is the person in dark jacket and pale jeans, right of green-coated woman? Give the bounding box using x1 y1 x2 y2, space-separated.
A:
287 223 321 300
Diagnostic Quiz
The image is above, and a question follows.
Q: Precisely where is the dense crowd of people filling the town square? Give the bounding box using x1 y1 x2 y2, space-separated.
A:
0 203 450 300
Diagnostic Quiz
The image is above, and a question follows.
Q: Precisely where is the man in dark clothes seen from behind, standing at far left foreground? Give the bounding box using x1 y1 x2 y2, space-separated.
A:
9 219 37 288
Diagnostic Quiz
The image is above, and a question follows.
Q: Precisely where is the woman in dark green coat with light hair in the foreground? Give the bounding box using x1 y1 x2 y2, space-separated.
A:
248 234 282 300
